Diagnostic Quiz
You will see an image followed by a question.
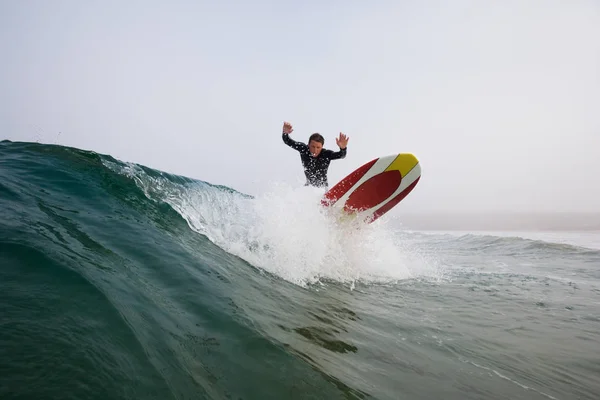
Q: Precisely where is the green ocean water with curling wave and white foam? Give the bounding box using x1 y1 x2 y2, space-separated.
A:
0 141 600 400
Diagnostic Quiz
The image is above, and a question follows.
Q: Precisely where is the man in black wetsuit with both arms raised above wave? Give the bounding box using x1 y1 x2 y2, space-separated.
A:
281 122 349 188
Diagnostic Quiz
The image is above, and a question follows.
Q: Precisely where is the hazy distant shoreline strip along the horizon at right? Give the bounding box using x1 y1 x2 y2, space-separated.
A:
395 212 600 231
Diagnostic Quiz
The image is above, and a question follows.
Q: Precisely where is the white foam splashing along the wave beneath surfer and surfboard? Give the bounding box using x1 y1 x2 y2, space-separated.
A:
170 180 441 286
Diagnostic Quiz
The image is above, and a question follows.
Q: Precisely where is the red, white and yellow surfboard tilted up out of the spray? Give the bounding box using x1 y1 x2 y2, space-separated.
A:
321 153 421 223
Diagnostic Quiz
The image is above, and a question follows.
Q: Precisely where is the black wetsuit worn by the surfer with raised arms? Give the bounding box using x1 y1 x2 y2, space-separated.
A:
282 133 346 188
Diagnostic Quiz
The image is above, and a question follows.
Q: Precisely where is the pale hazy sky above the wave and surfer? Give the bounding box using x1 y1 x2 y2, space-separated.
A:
0 0 600 213
